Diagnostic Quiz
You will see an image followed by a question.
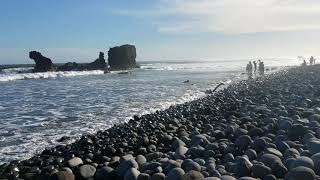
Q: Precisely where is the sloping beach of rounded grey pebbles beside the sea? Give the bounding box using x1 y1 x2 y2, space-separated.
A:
0 65 320 180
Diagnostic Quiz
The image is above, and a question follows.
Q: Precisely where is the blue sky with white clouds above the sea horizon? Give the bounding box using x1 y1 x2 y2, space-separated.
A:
0 0 320 64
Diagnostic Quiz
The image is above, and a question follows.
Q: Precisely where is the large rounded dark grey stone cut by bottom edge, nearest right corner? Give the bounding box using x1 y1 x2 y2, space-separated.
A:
284 166 316 180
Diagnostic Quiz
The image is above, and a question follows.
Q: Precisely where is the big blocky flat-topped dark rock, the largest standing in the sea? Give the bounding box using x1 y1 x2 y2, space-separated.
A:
108 44 138 70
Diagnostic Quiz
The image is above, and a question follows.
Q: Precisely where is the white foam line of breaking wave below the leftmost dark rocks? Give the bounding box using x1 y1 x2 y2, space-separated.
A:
0 70 104 82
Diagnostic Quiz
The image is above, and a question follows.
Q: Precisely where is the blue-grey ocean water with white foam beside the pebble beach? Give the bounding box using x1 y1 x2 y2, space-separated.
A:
0 59 301 163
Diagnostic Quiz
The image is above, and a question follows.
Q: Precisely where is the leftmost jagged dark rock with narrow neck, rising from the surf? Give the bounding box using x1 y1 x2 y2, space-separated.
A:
29 51 56 72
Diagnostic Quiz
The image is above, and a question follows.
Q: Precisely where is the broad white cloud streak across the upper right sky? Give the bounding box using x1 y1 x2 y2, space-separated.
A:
117 0 320 34
